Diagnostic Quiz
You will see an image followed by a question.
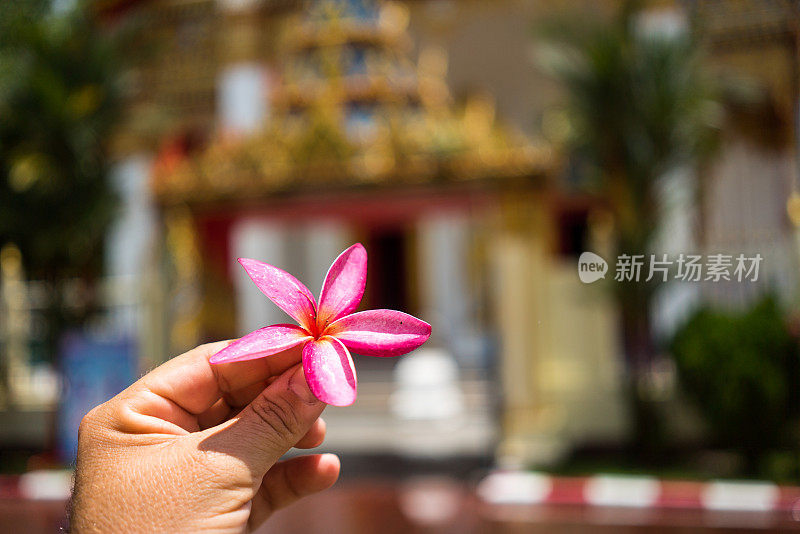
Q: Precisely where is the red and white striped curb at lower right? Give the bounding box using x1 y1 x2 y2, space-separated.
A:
478 471 800 512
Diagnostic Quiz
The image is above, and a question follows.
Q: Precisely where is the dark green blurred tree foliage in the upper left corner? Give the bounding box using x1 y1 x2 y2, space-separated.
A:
0 1 118 281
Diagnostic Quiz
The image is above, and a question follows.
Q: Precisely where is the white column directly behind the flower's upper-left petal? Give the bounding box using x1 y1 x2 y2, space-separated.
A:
231 219 286 335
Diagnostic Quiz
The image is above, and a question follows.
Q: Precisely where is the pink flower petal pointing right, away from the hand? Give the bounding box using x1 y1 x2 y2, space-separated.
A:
325 310 431 356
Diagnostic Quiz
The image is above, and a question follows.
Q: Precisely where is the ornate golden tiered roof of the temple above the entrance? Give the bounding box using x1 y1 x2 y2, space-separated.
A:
153 0 552 204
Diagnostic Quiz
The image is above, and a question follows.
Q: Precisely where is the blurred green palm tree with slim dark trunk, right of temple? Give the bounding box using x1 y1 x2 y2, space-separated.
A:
542 2 720 458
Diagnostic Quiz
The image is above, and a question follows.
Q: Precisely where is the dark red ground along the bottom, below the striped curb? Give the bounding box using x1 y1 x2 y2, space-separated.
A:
0 479 800 534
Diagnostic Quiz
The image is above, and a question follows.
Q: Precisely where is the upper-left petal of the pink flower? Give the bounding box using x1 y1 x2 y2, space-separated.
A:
239 258 317 331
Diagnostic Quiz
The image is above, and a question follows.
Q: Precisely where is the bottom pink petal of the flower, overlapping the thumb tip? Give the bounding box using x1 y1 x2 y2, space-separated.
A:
303 336 356 406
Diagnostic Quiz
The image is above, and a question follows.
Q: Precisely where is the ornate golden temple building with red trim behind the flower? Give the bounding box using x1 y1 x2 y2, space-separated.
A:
95 0 624 463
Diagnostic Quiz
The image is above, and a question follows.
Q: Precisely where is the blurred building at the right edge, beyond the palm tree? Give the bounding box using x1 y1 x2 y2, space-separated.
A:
686 0 800 306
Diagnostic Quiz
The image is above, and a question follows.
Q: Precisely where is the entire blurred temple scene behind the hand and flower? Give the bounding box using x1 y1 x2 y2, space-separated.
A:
0 0 800 533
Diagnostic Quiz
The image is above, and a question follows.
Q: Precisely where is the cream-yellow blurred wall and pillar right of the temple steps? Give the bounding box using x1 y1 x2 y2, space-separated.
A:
490 196 626 466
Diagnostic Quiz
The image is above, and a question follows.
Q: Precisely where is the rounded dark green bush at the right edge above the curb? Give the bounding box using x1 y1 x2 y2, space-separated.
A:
672 297 800 471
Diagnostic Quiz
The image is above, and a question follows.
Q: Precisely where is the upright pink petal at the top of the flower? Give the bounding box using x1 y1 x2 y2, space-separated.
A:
317 247 367 331
